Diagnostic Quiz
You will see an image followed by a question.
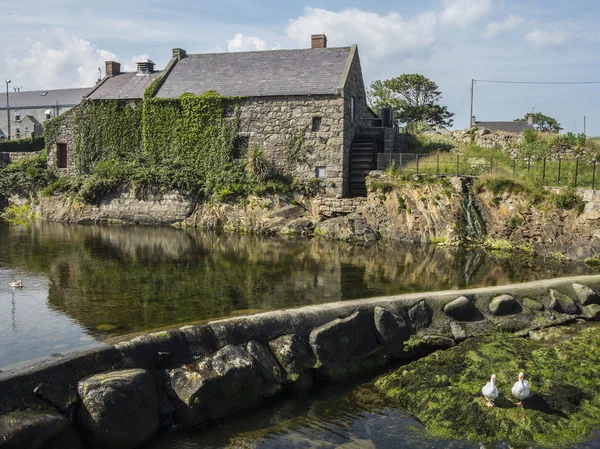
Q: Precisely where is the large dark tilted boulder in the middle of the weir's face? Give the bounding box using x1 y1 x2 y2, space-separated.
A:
309 310 385 381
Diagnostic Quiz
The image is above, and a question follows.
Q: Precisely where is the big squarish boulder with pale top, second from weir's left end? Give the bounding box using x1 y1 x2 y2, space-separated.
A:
77 369 159 449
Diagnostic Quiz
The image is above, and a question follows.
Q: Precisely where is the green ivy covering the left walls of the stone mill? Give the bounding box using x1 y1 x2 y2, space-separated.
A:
45 87 290 202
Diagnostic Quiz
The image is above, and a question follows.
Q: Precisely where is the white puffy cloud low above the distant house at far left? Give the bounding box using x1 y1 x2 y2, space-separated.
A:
4 29 117 90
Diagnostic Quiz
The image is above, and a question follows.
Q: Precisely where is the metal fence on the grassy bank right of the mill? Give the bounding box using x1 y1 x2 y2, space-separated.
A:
377 153 597 189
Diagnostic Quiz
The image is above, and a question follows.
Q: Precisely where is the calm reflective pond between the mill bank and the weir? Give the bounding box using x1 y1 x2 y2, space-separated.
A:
0 223 593 369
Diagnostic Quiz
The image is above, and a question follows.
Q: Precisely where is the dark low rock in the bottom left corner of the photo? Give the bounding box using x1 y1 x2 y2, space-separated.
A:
0 410 80 449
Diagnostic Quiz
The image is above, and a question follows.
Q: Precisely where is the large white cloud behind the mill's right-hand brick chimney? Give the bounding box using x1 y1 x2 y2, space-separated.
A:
286 8 436 58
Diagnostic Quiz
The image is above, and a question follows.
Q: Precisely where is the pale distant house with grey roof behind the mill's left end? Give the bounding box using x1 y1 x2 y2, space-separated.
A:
0 87 90 139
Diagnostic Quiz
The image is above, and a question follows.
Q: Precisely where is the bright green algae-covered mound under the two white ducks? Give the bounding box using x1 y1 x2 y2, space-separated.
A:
376 327 600 448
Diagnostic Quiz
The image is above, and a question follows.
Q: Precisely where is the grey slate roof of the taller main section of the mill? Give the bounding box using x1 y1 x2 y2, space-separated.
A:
156 47 351 98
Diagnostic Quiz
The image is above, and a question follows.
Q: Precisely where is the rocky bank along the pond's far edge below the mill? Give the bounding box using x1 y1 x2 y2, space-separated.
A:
4 172 600 260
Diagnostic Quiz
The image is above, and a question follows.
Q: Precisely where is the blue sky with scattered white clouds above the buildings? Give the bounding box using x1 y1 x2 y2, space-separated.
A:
0 0 600 136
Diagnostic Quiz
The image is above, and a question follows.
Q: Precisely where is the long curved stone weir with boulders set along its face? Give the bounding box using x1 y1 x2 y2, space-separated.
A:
0 276 600 449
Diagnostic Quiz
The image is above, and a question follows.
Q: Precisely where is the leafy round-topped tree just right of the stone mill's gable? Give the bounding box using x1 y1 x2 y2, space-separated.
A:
369 73 454 130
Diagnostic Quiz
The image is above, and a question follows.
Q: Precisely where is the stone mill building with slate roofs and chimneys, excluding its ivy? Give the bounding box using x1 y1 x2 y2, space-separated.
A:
48 35 393 196
